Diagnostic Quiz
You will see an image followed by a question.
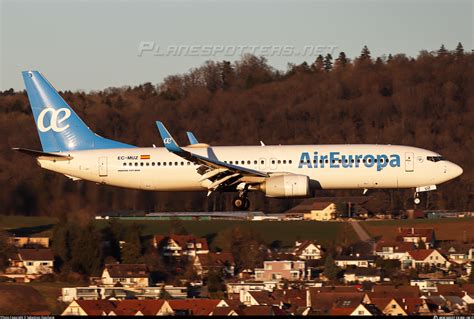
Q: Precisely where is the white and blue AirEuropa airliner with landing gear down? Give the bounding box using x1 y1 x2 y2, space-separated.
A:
15 71 463 210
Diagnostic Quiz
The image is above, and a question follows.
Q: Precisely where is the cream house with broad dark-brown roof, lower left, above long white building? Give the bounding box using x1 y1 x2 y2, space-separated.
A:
101 264 150 287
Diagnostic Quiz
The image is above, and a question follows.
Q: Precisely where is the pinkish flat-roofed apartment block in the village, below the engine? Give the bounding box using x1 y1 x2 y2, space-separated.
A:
255 260 306 281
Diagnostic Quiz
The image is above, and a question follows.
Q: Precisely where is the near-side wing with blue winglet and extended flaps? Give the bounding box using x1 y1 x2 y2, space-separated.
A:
156 121 269 194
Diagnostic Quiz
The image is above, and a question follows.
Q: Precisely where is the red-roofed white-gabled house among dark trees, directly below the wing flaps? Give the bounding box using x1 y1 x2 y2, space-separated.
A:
153 235 209 257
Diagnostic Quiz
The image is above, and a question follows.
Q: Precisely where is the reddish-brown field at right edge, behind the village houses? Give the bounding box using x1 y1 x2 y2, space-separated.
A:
361 217 474 241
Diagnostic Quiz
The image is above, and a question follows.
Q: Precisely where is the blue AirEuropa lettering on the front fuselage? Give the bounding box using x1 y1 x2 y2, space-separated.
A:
298 152 400 171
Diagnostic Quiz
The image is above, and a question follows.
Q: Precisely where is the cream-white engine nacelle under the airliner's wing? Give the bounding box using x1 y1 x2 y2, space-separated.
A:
260 175 310 197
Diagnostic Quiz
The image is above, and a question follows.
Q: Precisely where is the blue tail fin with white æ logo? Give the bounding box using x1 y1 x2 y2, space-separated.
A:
22 71 134 152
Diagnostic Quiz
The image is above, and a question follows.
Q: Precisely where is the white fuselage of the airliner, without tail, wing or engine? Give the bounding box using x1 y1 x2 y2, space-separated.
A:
38 145 462 191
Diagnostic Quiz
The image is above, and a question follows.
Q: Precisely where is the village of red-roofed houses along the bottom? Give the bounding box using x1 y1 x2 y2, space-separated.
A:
0 205 474 316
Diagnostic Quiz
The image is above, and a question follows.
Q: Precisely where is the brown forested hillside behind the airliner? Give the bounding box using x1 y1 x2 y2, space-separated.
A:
0 45 474 220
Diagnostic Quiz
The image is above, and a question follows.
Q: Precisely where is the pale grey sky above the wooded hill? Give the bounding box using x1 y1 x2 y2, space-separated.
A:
0 0 474 91
